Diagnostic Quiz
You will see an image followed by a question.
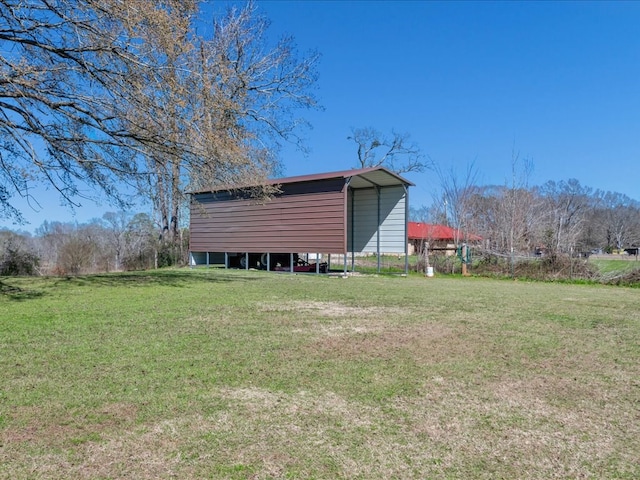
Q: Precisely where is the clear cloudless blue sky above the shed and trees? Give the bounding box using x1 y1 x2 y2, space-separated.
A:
5 0 640 229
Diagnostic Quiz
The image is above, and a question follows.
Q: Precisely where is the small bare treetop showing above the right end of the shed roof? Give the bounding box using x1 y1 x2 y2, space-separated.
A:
347 127 429 174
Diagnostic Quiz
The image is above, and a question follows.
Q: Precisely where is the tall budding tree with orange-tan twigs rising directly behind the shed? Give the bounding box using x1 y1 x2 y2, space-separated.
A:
132 3 318 255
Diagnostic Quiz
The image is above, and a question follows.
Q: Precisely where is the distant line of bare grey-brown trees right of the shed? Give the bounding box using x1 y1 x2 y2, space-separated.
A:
411 179 640 257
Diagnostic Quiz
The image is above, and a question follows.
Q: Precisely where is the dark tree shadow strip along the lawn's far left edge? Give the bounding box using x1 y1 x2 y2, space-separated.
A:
0 269 261 301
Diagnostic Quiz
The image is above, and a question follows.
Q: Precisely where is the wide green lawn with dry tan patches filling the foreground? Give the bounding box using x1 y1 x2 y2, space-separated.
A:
0 269 640 479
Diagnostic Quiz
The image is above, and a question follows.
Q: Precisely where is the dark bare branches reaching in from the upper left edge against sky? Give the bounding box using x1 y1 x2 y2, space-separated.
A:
0 0 192 220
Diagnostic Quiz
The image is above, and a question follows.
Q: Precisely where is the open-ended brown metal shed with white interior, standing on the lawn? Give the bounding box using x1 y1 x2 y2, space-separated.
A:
189 167 413 274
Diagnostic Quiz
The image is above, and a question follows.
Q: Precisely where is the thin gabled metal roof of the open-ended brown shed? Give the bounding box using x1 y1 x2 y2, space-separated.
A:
190 167 415 193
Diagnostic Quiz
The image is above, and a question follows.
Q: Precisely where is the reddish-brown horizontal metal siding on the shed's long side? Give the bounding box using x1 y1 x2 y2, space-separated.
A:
190 178 346 253
